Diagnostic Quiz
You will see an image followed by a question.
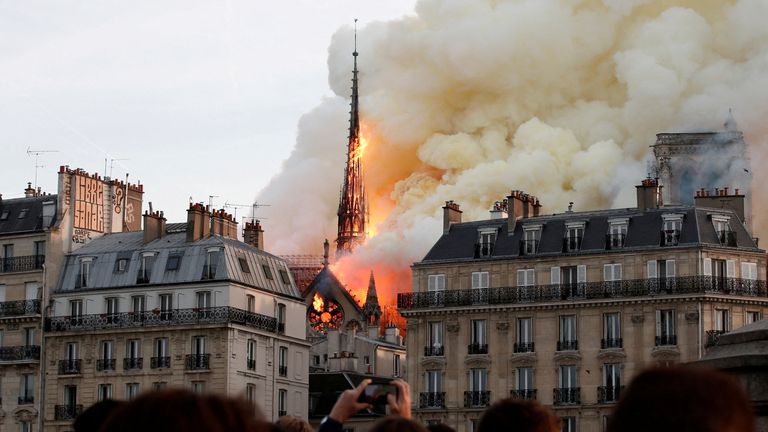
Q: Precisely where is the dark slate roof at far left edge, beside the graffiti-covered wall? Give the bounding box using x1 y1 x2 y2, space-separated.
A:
0 195 57 235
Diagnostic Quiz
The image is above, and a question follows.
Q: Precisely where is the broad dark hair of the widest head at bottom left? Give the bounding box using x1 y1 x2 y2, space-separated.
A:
101 389 273 432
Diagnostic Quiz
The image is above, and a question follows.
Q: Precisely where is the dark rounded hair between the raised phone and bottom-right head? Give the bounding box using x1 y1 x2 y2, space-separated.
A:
477 398 560 432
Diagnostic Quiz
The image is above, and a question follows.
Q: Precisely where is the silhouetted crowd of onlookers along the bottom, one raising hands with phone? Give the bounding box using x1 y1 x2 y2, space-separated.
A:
74 366 755 432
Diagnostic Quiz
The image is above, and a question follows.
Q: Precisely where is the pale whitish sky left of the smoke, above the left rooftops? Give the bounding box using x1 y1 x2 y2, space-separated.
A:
0 0 414 222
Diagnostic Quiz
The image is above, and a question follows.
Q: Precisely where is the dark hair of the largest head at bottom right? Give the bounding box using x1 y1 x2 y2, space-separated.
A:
608 366 755 432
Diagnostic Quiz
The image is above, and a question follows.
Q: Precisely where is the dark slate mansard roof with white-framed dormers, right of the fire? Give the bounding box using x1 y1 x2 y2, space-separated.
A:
422 206 761 263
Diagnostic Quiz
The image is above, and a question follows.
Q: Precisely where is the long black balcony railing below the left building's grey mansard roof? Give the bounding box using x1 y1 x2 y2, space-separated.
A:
45 303 277 333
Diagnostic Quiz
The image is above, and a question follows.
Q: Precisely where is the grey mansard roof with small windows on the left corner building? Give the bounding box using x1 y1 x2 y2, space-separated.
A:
57 230 302 299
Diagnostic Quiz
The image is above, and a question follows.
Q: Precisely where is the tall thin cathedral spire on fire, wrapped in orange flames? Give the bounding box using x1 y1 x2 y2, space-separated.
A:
336 19 368 258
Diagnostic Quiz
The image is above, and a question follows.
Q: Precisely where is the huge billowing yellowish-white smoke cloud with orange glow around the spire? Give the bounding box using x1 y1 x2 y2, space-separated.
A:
259 0 768 300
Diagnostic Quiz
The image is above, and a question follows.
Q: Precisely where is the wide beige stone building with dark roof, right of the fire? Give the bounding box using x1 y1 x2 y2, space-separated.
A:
398 179 768 432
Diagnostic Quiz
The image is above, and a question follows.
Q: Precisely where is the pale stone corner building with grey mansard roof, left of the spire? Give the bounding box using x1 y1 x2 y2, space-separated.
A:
41 204 309 431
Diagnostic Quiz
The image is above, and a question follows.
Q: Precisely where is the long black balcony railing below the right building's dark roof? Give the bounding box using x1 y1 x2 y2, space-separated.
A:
397 276 768 310
